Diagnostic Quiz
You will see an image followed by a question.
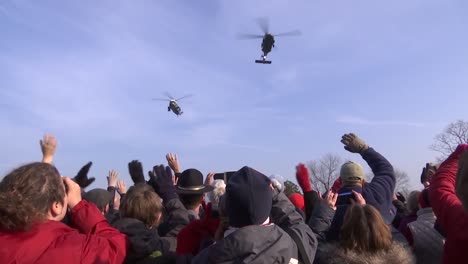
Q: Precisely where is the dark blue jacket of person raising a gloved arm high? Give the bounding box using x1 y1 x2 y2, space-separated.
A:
327 148 396 240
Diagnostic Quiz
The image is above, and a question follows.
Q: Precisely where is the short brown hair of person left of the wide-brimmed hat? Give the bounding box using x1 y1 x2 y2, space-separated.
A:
120 183 163 228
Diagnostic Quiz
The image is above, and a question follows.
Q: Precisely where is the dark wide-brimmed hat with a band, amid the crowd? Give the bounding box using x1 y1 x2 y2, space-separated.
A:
176 169 214 194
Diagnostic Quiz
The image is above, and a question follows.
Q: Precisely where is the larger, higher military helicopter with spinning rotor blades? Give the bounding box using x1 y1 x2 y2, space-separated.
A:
238 18 301 64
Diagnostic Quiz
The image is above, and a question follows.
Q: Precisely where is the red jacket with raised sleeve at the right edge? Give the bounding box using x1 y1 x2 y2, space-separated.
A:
429 144 468 264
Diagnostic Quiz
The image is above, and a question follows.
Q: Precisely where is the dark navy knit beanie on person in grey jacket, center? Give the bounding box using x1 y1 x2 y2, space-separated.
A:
226 166 273 227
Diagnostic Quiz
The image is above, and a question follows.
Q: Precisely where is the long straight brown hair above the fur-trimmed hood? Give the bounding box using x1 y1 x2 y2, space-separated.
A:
340 205 392 253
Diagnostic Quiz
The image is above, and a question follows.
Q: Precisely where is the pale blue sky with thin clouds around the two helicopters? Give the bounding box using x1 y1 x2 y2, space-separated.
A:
0 0 468 191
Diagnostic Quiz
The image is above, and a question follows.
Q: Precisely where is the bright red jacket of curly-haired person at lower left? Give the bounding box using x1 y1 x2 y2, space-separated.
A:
0 200 127 264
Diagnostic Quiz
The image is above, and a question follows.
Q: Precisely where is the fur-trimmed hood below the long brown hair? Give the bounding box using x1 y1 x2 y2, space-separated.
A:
319 243 416 264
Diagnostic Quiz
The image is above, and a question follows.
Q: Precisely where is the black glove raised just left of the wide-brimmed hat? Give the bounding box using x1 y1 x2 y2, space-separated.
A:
148 165 178 203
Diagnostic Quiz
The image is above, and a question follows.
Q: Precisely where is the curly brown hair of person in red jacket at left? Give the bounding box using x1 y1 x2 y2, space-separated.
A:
0 162 65 231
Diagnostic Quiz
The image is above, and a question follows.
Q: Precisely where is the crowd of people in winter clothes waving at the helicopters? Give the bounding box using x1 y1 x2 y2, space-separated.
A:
0 133 468 264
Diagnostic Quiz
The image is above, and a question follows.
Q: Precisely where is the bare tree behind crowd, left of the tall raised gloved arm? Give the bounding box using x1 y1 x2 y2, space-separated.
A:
308 153 342 193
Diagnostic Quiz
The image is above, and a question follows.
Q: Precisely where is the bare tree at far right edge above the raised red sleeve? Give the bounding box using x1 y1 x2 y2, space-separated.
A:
430 120 468 161
